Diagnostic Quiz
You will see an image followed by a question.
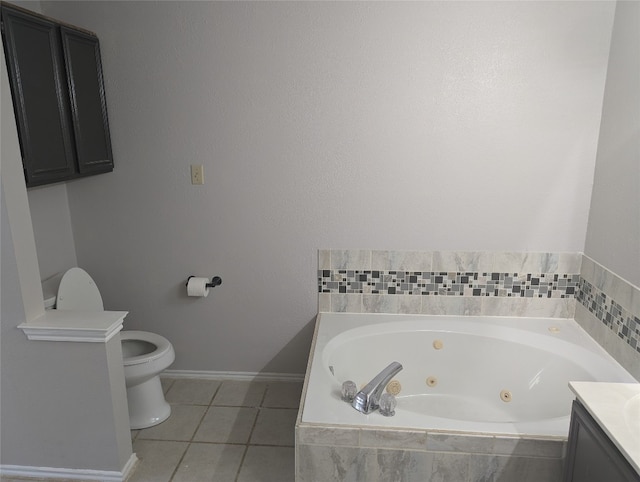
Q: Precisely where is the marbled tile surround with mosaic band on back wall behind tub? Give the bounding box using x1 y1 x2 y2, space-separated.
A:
318 250 580 318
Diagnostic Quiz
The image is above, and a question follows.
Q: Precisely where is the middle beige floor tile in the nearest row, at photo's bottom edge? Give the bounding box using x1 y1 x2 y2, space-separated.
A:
172 443 245 482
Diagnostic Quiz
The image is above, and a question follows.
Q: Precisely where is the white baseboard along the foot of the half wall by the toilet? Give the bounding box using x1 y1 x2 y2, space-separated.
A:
0 454 138 482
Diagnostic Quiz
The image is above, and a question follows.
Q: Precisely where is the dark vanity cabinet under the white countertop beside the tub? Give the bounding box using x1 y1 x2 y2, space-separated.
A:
563 401 640 482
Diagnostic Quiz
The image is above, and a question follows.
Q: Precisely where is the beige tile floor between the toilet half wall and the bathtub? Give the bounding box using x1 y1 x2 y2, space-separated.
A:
1 378 302 482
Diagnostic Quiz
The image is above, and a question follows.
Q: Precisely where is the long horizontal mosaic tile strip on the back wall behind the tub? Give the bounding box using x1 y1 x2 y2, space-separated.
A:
318 269 580 298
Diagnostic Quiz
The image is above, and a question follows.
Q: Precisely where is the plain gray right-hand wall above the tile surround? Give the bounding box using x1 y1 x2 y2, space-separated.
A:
584 2 640 287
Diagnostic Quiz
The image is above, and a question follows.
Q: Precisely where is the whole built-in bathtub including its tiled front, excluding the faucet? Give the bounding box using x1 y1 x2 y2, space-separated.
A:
296 313 636 481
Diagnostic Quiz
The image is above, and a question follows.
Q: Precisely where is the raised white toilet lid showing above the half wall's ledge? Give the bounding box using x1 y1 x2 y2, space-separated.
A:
56 268 104 311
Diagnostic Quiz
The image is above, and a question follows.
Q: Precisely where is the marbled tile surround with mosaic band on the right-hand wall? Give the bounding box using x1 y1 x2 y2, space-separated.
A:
575 256 640 380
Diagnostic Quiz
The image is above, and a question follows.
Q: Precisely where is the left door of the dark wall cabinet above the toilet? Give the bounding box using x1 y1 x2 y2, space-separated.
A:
2 6 75 186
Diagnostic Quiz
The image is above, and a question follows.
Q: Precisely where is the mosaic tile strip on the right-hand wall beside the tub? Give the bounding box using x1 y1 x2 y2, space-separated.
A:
576 278 640 353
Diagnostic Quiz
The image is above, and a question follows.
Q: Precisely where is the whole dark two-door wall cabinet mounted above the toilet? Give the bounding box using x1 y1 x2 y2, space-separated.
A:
2 3 113 186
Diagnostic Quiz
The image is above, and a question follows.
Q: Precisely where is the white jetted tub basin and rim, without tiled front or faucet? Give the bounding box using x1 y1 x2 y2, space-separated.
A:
300 313 636 438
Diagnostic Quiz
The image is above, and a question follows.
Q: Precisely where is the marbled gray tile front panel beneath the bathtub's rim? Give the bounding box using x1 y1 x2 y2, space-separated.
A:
296 424 566 482
